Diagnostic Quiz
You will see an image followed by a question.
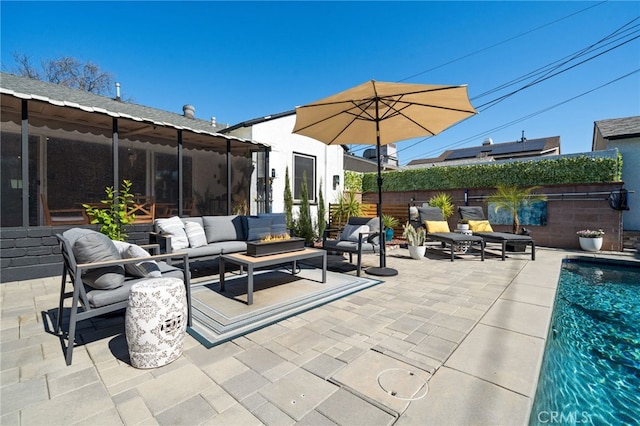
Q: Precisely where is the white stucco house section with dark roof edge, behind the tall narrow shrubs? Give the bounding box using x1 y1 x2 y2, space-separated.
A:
222 111 344 220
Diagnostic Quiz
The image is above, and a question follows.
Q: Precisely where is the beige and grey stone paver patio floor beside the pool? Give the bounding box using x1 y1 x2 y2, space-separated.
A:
0 248 636 426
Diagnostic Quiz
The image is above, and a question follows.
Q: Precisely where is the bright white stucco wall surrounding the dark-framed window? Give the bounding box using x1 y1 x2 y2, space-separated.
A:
234 115 344 220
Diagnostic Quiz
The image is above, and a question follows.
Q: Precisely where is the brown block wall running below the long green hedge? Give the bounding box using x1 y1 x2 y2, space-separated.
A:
362 182 623 251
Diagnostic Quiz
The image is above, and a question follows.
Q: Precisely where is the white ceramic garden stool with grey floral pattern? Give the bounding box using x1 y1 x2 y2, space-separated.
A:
125 278 188 368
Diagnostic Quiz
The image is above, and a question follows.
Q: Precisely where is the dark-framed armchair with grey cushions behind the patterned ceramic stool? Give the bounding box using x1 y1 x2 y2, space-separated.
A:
55 228 191 365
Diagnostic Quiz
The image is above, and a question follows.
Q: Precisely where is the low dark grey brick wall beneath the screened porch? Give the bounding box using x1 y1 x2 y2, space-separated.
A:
0 224 152 283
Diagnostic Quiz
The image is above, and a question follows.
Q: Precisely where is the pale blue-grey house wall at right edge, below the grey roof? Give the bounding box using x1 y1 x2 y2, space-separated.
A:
607 138 640 231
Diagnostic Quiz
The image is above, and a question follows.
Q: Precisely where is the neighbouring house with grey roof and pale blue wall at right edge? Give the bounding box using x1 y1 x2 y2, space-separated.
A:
591 116 640 231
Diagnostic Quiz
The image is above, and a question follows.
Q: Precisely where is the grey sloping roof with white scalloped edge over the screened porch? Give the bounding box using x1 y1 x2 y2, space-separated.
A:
0 72 266 146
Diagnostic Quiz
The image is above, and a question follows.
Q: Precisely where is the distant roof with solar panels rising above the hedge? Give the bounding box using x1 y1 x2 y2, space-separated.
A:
407 136 560 167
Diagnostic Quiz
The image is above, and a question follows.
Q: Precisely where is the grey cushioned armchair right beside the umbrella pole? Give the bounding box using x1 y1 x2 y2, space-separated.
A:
322 217 380 276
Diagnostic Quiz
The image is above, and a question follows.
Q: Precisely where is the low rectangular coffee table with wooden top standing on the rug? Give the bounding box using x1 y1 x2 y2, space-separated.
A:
220 248 327 305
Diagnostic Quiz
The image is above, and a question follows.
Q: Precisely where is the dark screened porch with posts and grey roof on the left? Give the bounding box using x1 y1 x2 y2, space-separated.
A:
0 73 268 228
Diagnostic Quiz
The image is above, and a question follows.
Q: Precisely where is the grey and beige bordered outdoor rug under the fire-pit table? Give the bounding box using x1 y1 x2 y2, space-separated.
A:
187 263 383 348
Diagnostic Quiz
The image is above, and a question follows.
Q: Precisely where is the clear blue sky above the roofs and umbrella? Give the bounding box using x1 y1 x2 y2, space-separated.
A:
0 0 640 164
